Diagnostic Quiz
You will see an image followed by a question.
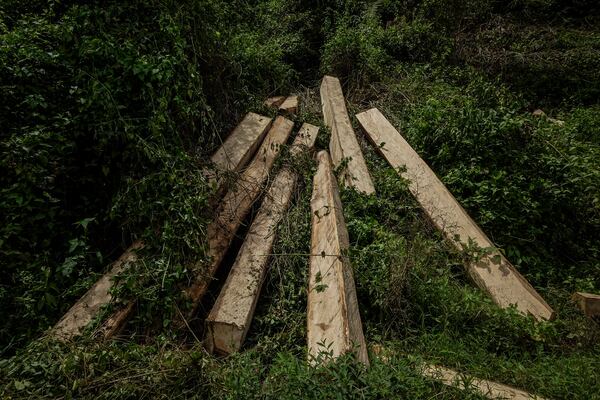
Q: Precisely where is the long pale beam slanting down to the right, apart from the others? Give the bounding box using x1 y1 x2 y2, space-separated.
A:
356 108 554 320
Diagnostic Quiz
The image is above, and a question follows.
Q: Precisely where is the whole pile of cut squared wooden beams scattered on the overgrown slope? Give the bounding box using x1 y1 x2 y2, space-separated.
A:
51 76 556 399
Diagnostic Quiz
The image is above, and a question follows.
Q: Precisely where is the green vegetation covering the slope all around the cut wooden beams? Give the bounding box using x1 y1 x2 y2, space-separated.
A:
0 0 600 399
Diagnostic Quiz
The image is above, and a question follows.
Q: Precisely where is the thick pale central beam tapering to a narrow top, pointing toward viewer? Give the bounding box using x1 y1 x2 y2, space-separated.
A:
307 151 369 365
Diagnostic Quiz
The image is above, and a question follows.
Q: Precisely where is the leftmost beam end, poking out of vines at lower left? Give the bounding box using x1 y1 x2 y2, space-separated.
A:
49 241 143 340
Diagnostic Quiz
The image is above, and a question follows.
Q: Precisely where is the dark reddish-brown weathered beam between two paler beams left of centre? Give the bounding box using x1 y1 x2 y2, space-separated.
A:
187 116 294 316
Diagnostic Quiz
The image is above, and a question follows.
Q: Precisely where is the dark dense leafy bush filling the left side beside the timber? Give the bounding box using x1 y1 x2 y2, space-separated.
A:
0 1 303 354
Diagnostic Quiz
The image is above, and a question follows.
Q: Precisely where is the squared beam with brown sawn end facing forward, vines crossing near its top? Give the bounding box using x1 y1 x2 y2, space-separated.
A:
206 124 319 354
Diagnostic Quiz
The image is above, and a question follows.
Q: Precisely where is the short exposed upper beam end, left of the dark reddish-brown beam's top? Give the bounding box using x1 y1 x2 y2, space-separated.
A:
211 113 271 175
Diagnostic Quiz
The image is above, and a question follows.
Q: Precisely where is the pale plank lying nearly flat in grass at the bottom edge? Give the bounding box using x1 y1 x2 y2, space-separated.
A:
421 365 544 400
